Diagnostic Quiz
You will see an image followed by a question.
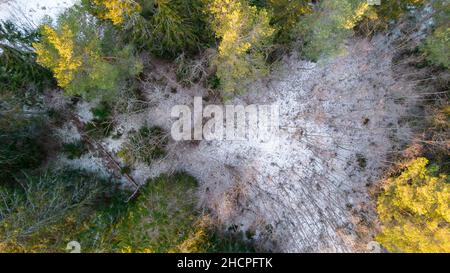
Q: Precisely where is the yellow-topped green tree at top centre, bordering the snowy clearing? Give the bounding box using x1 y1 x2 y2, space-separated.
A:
206 0 275 96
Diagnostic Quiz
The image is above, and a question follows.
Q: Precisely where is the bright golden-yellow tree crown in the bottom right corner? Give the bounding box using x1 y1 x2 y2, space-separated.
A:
377 158 450 252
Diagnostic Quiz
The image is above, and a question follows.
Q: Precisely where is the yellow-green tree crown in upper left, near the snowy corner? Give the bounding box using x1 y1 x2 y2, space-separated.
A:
33 6 142 99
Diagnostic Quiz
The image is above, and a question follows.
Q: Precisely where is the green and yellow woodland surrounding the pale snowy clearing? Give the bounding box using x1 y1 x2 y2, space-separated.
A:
0 0 450 252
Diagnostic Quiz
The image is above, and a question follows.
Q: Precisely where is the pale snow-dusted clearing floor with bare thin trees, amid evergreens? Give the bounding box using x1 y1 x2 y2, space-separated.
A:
50 36 422 252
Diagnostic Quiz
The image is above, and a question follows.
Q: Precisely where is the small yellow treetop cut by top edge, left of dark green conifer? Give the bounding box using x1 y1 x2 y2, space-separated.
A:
93 0 142 25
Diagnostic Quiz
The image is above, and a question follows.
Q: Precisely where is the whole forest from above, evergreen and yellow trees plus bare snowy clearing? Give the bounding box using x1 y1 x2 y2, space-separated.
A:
0 0 450 253
